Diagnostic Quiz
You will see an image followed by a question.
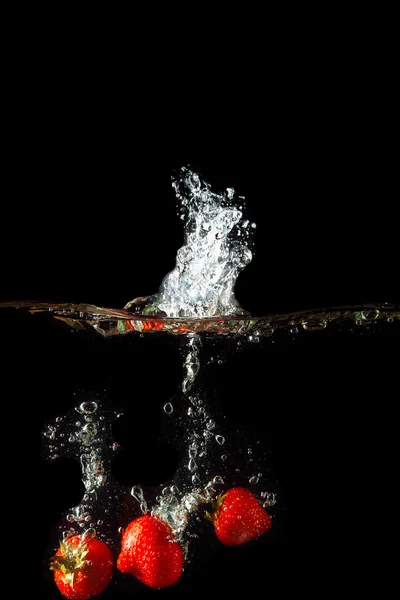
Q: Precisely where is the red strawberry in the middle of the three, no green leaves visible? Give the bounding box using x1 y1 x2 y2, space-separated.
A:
117 515 183 588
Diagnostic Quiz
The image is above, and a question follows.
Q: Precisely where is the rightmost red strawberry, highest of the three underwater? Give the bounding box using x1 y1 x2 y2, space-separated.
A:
211 487 271 546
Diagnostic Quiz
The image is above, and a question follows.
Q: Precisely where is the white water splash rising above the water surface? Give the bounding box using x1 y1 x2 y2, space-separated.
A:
125 167 255 317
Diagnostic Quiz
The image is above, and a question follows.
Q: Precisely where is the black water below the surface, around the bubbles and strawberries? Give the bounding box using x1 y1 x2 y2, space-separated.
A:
0 308 400 599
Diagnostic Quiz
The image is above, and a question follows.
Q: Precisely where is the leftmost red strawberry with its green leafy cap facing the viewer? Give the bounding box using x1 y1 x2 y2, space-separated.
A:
50 535 113 600
